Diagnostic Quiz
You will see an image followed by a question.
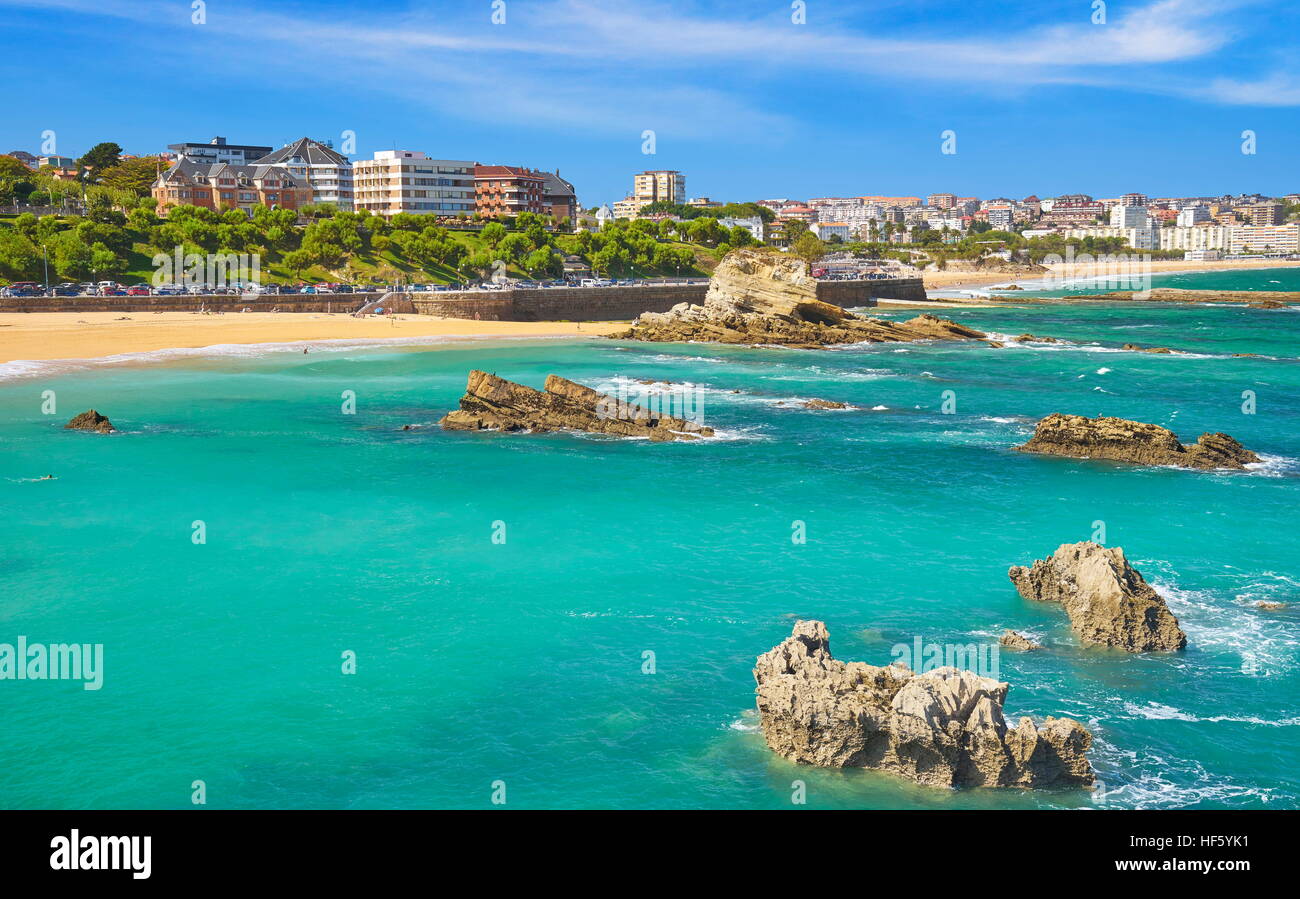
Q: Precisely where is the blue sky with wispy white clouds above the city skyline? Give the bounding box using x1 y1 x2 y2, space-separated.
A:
0 0 1300 204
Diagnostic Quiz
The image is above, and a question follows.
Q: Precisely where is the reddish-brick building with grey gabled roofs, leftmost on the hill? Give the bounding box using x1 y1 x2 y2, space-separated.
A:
152 157 312 216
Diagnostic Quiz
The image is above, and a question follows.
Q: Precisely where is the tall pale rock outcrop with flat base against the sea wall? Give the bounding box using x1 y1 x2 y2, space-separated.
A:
611 248 984 348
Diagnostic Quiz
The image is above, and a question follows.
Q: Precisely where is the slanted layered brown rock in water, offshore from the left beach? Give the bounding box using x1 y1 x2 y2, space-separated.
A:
439 370 714 440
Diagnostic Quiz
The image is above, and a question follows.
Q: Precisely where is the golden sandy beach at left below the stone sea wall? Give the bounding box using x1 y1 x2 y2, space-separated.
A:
0 312 627 362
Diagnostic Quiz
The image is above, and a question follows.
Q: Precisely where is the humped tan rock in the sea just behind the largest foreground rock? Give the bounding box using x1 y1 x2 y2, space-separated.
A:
1008 542 1187 652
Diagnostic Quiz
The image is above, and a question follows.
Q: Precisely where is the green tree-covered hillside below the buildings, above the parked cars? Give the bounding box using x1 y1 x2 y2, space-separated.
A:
0 200 745 285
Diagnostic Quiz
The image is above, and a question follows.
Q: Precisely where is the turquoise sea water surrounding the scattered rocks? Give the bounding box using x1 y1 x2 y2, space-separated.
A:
0 291 1300 808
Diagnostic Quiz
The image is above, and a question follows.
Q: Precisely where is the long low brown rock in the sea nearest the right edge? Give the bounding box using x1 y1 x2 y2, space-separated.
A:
1017 412 1260 469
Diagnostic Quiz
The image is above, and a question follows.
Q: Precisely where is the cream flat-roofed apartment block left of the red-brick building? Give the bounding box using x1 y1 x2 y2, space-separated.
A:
352 149 476 218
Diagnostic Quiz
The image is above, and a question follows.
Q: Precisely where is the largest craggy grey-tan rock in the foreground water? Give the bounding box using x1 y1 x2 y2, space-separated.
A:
754 621 1093 787
